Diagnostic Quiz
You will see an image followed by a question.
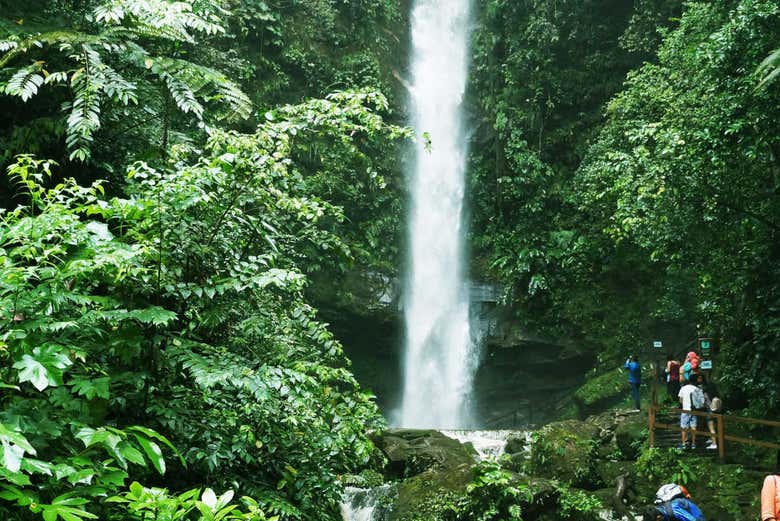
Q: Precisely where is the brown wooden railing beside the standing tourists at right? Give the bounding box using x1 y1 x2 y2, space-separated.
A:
647 389 780 459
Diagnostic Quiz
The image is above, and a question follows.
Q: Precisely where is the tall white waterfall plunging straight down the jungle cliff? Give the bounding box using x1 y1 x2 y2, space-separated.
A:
400 0 477 428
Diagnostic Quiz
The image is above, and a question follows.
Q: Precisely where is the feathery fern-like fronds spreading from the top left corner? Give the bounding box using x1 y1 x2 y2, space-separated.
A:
0 0 252 161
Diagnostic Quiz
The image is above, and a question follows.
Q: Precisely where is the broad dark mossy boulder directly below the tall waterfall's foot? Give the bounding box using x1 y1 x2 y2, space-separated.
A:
373 429 478 479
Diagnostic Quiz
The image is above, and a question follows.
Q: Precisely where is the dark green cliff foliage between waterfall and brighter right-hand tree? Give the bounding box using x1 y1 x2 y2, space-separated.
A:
470 0 680 354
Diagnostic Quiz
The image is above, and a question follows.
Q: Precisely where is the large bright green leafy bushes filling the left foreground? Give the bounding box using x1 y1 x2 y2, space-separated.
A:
0 88 409 520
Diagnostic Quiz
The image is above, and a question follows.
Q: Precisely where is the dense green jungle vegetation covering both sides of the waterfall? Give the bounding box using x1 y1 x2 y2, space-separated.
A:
0 0 780 521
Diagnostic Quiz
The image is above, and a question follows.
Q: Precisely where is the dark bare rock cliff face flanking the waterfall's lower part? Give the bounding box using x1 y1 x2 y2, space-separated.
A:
320 278 593 429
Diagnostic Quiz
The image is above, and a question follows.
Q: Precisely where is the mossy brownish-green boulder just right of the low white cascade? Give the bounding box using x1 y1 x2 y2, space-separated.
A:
528 420 600 488
